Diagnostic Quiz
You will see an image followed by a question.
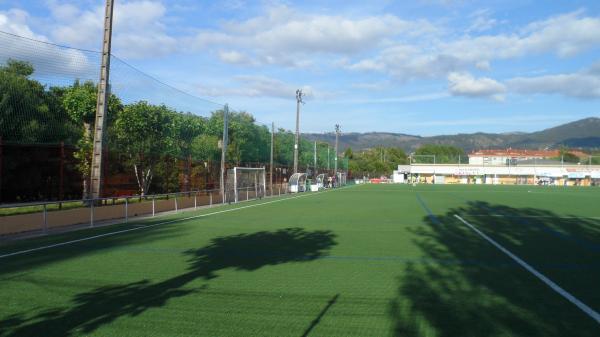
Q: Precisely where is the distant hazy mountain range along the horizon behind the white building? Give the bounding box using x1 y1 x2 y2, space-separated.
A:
302 117 600 152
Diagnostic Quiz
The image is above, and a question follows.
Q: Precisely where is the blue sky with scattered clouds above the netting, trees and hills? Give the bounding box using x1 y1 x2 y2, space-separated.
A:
0 0 600 135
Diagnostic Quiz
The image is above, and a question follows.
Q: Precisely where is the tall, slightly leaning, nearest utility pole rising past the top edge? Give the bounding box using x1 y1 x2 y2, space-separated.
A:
86 0 114 199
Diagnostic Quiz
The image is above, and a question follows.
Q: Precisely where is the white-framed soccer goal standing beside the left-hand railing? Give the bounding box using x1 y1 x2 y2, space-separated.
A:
225 167 267 202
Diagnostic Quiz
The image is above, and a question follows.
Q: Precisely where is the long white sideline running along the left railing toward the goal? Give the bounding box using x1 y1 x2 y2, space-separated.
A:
0 189 332 259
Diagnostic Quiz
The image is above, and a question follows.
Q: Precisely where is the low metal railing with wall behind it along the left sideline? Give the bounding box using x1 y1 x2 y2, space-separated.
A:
0 184 289 238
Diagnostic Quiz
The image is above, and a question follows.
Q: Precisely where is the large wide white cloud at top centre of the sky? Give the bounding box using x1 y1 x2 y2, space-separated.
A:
193 6 437 66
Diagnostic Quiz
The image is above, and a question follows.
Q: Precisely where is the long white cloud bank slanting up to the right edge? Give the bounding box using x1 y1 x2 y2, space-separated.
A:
347 11 600 80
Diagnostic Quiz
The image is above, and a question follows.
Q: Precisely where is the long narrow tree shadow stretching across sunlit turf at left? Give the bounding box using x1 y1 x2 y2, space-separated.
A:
0 228 336 336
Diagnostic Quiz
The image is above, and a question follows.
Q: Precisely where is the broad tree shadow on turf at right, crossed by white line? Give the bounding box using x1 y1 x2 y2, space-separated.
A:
389 201 600 337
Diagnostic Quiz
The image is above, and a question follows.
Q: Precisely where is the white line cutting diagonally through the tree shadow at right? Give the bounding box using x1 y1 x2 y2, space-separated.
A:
454 214 600 323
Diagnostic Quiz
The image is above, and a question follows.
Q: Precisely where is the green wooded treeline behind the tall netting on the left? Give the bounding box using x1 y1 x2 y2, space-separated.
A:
0 60 333 201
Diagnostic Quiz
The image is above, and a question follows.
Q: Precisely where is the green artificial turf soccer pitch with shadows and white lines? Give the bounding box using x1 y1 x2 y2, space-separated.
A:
0 185 600 337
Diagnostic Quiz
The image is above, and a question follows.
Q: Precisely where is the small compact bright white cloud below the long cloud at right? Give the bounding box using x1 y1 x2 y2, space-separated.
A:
448 73 506 101
